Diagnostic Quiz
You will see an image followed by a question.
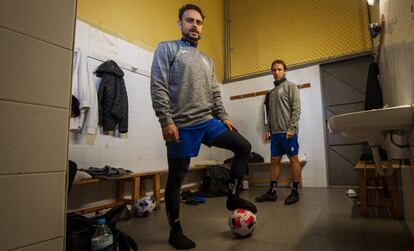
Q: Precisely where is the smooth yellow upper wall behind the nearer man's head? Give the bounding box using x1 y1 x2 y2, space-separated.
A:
77 0 224 82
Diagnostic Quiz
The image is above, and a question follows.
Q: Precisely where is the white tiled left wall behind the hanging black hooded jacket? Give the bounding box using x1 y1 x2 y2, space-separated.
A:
69 20 222 172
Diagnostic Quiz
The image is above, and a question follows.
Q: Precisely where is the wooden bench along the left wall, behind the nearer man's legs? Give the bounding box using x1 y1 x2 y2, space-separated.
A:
70 165 208 214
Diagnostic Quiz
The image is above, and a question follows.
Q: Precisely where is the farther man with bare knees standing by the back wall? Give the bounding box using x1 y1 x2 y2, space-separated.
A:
255 60 301 205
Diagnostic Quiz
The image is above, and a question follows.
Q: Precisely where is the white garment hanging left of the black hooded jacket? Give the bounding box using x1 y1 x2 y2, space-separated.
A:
70 50 98 134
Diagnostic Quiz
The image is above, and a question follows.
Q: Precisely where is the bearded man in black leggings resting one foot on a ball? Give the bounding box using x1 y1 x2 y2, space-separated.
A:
151 4 257 249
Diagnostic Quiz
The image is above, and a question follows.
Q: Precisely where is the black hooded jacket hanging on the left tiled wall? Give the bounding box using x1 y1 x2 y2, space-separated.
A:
96 60 128 133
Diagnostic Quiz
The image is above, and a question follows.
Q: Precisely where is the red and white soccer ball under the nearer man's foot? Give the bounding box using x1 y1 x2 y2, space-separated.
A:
229 208 257 237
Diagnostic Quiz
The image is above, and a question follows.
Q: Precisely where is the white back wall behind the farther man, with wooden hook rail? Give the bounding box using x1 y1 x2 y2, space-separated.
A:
222 66 327 187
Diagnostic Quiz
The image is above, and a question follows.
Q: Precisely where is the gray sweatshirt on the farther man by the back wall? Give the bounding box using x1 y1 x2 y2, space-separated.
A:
265 80 300 134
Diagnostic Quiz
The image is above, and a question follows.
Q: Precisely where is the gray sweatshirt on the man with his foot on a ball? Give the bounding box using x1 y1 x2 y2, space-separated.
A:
151 40 228 128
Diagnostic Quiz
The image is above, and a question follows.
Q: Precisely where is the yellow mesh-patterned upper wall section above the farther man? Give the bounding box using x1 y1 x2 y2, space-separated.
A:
228 0 371 79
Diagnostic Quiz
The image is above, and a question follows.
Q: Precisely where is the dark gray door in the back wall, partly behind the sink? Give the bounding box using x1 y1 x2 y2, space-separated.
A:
320 56 373 186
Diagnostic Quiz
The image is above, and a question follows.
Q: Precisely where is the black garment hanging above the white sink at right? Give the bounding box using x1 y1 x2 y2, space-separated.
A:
365 62 383 110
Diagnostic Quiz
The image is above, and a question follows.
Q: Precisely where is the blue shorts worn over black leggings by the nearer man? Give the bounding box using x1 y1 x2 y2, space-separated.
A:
166 118 227 159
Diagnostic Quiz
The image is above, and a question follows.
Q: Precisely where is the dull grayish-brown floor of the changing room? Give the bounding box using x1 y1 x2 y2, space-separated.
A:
119 188 414 251
